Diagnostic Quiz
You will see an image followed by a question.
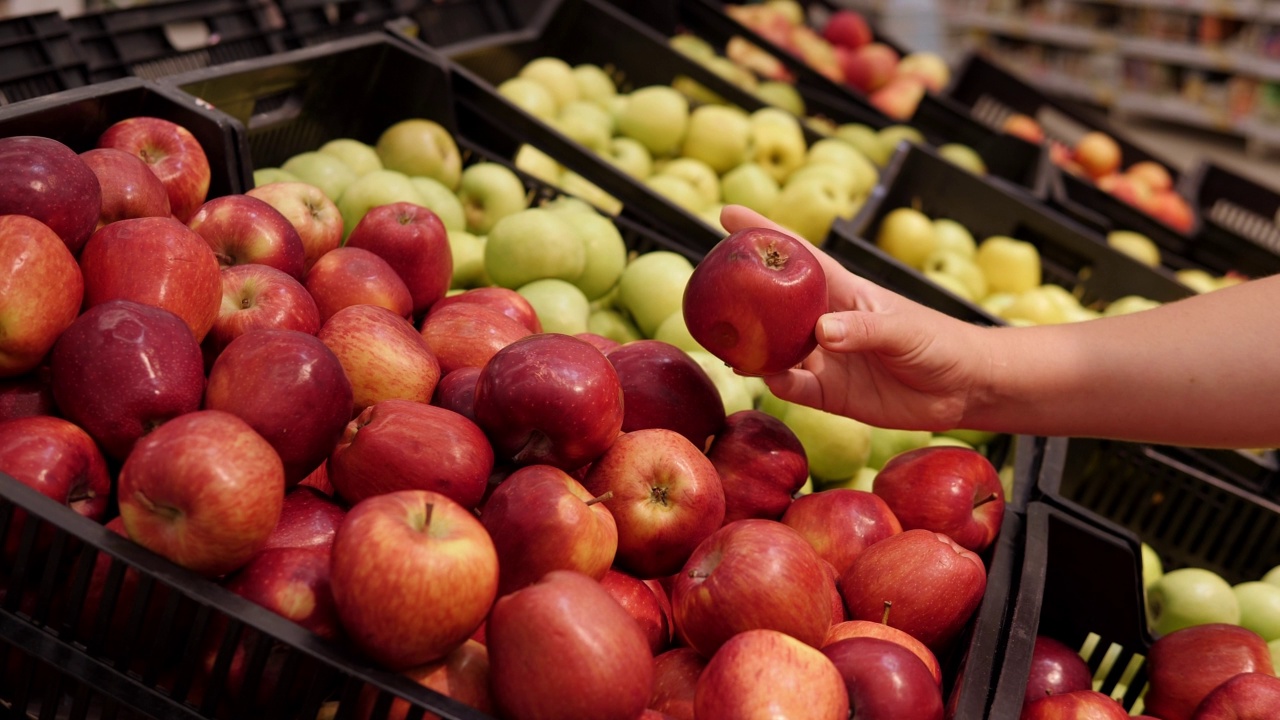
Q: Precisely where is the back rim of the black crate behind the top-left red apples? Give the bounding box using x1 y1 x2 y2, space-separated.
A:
0 78 253 197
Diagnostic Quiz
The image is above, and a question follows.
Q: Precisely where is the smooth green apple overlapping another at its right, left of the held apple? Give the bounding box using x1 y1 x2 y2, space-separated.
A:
484 208 586 286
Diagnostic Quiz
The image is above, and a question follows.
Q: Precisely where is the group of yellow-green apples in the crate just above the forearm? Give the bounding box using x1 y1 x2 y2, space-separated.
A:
876 208 1160 325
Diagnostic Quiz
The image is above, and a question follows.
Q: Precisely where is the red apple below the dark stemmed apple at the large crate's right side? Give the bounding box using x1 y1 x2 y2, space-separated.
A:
840 530 987 653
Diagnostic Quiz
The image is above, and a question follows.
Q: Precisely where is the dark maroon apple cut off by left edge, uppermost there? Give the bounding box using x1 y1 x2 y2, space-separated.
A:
0 136 102 255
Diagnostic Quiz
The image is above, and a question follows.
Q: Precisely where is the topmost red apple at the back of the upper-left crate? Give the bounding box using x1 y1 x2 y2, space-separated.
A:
97 117 211 223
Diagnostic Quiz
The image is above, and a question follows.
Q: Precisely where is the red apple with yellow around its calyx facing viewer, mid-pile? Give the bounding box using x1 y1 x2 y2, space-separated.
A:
582 428 724 578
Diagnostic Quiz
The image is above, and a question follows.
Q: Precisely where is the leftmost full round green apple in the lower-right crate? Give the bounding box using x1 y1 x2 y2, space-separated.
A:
1147 568 1240 635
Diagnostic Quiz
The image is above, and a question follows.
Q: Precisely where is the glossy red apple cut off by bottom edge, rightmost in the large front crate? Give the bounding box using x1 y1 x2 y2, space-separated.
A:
822 637 942 720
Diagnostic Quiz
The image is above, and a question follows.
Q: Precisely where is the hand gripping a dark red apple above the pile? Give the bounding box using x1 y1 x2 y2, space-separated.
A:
721 205 992 430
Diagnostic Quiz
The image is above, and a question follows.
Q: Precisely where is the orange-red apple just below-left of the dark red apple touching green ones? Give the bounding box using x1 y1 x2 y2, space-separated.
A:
306 247 413 322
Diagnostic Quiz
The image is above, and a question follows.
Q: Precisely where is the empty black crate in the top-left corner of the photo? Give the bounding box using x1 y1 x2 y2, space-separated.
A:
0 13 90 105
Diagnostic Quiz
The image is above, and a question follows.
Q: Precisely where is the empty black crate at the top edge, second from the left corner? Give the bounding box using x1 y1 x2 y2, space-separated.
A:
70 0 284 82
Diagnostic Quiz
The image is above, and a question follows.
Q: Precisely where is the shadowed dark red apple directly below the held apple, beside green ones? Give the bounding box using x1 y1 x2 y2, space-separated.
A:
707 410 809 523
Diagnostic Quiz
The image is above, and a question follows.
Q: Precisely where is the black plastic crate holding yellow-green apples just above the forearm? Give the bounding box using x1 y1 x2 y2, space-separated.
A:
832 145 1192 324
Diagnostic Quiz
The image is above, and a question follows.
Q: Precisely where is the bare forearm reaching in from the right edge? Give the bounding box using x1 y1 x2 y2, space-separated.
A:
965 277 1280 447
